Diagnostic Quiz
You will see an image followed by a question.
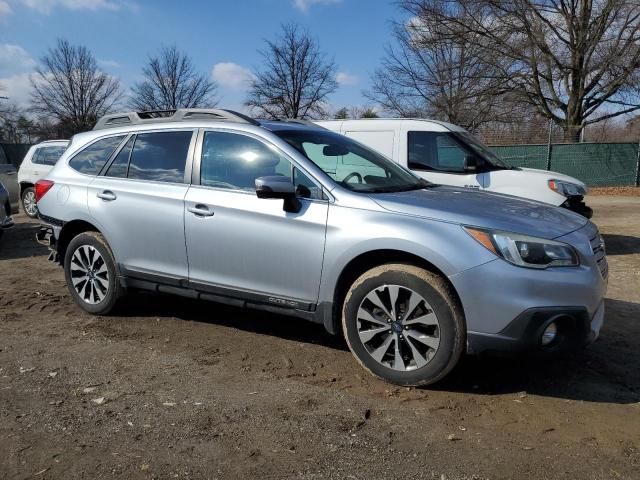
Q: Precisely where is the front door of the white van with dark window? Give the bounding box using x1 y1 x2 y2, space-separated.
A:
407 131 484 189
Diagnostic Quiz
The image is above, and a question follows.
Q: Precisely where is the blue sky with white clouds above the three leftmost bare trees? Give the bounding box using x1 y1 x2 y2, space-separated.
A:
0 0 400 114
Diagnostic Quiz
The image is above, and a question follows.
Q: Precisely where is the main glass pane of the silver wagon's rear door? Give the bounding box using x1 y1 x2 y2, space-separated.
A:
129 131 193 183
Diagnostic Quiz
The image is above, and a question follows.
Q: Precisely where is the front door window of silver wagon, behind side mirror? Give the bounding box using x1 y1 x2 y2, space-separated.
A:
200 132 321 198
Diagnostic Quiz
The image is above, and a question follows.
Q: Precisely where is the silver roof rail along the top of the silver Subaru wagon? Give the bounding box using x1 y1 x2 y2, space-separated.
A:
93 108 260 130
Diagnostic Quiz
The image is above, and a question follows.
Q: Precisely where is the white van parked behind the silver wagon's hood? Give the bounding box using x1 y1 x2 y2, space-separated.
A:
316 118 593 218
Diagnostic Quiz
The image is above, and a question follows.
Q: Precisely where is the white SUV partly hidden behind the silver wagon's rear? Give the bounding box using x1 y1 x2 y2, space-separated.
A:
18 140 69 218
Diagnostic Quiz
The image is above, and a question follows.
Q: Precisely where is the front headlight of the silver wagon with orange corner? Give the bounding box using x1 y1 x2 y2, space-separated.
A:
464 227 580 268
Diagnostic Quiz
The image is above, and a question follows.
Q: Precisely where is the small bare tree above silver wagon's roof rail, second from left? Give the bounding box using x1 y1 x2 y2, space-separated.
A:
129 46 218 111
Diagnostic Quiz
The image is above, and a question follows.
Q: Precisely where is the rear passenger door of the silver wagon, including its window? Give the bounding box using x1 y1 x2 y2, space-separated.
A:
88 130 195 284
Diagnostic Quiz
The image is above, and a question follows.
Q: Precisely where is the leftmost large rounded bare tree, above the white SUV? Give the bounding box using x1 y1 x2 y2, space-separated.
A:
31 40 122 136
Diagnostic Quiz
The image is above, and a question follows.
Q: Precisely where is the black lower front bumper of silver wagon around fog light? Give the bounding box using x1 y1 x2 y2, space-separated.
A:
467 302 604 354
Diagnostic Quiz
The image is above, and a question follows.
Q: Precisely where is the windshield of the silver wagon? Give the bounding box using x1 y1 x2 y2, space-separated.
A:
273 130 429 193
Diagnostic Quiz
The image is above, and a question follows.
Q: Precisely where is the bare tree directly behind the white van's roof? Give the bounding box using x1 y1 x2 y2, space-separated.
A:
365 1 508 129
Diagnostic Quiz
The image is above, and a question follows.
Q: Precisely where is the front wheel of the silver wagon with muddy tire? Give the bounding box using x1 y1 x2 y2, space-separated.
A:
342 264 466 386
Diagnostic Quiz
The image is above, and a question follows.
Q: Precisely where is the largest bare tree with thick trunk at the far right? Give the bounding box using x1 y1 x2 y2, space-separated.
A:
403 0 640 141
